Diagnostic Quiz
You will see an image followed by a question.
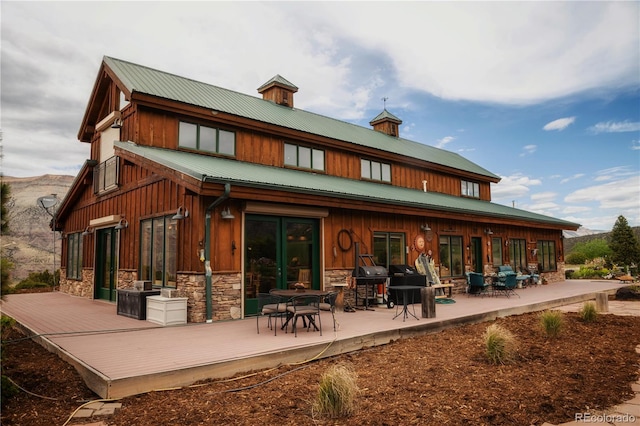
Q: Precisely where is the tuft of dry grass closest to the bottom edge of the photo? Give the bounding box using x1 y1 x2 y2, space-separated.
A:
313 363 358 419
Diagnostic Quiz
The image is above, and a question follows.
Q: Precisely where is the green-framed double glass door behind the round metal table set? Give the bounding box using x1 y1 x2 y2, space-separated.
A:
244 215 320 315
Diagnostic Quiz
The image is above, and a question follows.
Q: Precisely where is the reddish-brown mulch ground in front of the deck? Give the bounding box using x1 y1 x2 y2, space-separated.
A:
1 308 640 426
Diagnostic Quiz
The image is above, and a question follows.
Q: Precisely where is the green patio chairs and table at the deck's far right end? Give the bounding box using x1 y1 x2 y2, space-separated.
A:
467 266 540 297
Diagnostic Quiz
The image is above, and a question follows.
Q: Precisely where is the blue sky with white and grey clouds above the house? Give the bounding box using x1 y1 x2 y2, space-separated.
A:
1 1 640 231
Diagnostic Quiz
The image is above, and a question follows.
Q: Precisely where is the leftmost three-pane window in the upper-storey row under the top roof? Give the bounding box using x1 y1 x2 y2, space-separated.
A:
178 121 236 156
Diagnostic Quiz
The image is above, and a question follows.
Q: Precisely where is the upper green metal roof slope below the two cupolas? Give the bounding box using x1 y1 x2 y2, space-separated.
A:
104 56 500 180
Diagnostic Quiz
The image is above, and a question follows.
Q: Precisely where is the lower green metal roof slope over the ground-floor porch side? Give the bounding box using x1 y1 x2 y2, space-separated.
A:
115 142 579 229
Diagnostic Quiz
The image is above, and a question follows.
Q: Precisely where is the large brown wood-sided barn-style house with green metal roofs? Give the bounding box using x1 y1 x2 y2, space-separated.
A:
54 57 579 322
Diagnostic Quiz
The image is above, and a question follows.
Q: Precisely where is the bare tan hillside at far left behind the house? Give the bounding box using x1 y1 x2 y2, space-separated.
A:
0 175 74 283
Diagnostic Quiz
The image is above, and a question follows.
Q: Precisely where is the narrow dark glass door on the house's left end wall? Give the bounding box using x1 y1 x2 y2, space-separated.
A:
95 228 117 302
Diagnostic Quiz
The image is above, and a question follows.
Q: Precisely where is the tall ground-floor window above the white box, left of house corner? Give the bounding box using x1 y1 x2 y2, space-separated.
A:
139 216 177 288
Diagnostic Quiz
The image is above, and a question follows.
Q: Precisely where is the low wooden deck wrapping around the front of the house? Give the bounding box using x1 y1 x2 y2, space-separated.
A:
0 280 622 398
